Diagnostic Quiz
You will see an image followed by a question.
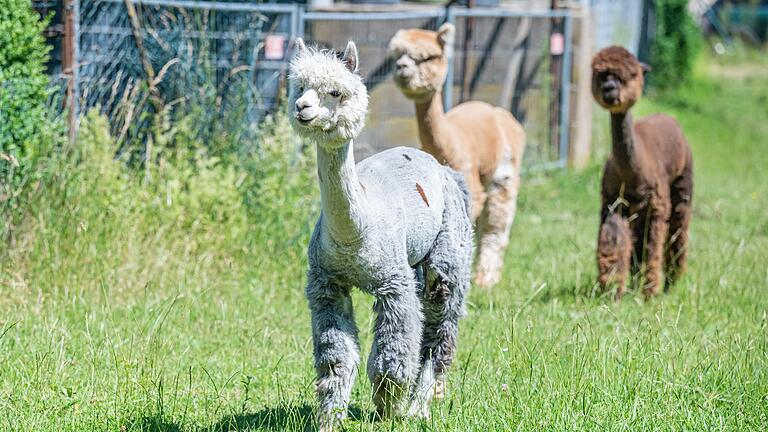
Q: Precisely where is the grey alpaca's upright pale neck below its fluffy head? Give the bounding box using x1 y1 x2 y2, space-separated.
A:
317 140 363 243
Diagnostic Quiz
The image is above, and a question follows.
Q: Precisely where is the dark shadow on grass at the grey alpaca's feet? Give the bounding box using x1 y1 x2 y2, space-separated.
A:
204 404 374 432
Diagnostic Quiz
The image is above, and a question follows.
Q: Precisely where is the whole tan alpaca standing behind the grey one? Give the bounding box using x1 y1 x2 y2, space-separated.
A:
389 24 525 286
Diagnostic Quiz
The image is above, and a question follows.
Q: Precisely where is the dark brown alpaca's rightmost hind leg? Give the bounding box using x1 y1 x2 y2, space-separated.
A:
664 169 693 290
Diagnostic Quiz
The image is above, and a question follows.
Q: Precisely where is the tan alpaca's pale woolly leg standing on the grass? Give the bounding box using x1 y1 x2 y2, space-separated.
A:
475 163 520 287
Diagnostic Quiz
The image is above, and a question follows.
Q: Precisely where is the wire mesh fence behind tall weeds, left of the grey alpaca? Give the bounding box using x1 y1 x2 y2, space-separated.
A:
79 0 295 148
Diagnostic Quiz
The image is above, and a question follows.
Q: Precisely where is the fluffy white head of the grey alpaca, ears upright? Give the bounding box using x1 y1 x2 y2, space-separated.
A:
289 39 368 149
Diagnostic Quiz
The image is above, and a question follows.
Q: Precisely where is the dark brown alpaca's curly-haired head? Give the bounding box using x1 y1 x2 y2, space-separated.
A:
592 46 649 113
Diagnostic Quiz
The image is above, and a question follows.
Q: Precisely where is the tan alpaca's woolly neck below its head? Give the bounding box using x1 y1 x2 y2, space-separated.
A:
416 91 454 163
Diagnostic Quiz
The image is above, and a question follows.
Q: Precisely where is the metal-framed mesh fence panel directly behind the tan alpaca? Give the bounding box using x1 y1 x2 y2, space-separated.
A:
300 8 572 166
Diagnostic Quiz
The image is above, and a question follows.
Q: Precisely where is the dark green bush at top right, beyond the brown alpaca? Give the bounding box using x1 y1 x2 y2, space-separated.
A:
648 0 701 91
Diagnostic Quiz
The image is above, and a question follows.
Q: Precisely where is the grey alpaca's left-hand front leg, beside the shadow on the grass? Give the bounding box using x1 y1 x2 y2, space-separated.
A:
307 271 360 432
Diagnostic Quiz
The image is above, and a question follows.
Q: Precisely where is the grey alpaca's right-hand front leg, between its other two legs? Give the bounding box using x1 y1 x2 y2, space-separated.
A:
368 274 423 418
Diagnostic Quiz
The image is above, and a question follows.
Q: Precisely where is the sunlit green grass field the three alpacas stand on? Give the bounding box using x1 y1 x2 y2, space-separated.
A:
0 55 768 432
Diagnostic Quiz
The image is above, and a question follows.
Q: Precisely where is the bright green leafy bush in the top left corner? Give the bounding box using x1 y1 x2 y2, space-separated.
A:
0 0 49 159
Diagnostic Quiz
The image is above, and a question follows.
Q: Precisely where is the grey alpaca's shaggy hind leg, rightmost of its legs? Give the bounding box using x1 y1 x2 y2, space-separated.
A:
409 177 473 418
